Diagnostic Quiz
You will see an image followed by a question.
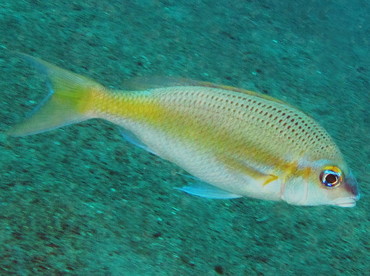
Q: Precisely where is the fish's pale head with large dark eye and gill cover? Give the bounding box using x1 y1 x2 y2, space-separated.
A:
283 160 360 207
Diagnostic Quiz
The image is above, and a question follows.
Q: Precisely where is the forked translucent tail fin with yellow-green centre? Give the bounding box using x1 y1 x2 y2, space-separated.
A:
8 54 104 136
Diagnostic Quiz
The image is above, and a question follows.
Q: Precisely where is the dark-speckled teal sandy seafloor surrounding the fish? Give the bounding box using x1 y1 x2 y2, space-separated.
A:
0 0 370 275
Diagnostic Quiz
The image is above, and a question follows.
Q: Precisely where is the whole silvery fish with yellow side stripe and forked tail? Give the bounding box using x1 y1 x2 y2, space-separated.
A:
8 55 360 207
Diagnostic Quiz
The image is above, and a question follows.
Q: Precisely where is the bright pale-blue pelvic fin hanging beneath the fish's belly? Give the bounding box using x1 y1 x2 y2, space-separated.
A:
176 181 242 199
